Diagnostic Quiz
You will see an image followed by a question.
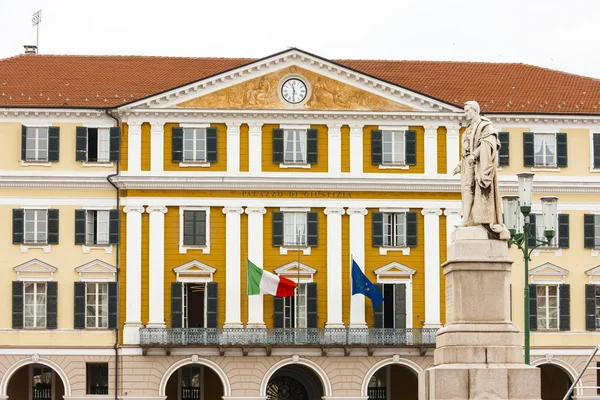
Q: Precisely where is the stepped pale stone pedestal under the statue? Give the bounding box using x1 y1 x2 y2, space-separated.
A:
419 227 540 400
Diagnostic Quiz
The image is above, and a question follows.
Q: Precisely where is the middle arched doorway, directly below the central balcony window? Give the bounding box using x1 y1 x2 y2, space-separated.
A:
267 364 324 400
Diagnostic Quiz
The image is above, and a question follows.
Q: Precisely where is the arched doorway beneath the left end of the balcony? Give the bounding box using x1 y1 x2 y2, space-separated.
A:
165 364 224 400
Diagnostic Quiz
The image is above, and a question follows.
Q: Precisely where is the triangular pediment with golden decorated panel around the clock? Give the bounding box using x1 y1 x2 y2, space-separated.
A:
121 49 462 112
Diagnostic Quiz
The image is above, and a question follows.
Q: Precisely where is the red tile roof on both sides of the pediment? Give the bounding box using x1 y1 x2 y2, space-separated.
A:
0 55 600 114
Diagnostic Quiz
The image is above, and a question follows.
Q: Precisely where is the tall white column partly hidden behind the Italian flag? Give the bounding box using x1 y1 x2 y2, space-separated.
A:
246 207 267 328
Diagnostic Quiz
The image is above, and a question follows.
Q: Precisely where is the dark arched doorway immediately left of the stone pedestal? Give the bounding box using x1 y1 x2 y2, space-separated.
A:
368 364 419 400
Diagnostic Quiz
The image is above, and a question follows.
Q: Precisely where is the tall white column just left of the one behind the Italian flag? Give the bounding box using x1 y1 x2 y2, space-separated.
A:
223 207 244 328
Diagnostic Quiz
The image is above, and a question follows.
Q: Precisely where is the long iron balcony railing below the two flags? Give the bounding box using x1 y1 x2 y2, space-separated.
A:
140 328 437 347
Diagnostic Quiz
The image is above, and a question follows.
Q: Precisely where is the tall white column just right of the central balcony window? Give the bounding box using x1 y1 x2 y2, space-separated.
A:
325 207 344 328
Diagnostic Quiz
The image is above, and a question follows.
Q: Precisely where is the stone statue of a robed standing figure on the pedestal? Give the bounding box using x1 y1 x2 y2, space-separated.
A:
454 101 510 240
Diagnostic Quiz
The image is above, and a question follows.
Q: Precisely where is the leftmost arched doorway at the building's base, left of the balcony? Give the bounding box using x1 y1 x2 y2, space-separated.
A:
6 364 65 400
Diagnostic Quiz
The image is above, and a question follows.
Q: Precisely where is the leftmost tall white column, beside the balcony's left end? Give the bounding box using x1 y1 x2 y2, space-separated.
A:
123 206 144 344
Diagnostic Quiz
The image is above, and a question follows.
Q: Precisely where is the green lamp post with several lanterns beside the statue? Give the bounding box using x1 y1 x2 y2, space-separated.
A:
502 172 558 364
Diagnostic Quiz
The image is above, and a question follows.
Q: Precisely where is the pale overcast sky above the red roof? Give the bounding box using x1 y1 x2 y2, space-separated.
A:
0 0 600 78
